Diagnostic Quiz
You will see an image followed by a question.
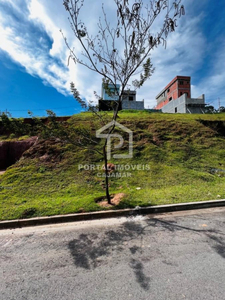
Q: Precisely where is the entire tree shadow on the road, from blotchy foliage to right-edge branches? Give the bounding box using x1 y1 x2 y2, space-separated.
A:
68 214 225 290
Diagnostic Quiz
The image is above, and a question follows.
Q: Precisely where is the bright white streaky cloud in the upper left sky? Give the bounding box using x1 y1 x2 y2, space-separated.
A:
0 0 85 95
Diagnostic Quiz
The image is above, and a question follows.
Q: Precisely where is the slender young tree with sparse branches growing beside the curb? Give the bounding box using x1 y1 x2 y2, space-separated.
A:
63 0 184 203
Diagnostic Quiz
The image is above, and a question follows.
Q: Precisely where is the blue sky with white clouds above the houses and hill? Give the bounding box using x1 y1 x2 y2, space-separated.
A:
0 0 225 117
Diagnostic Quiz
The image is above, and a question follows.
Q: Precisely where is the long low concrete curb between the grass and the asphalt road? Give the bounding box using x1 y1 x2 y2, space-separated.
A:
0 199 225 229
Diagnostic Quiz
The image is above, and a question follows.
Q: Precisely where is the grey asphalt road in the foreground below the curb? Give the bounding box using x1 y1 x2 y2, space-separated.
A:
0 208 225 300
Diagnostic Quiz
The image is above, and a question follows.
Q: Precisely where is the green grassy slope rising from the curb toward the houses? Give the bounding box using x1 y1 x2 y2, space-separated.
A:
0 112 225 220
